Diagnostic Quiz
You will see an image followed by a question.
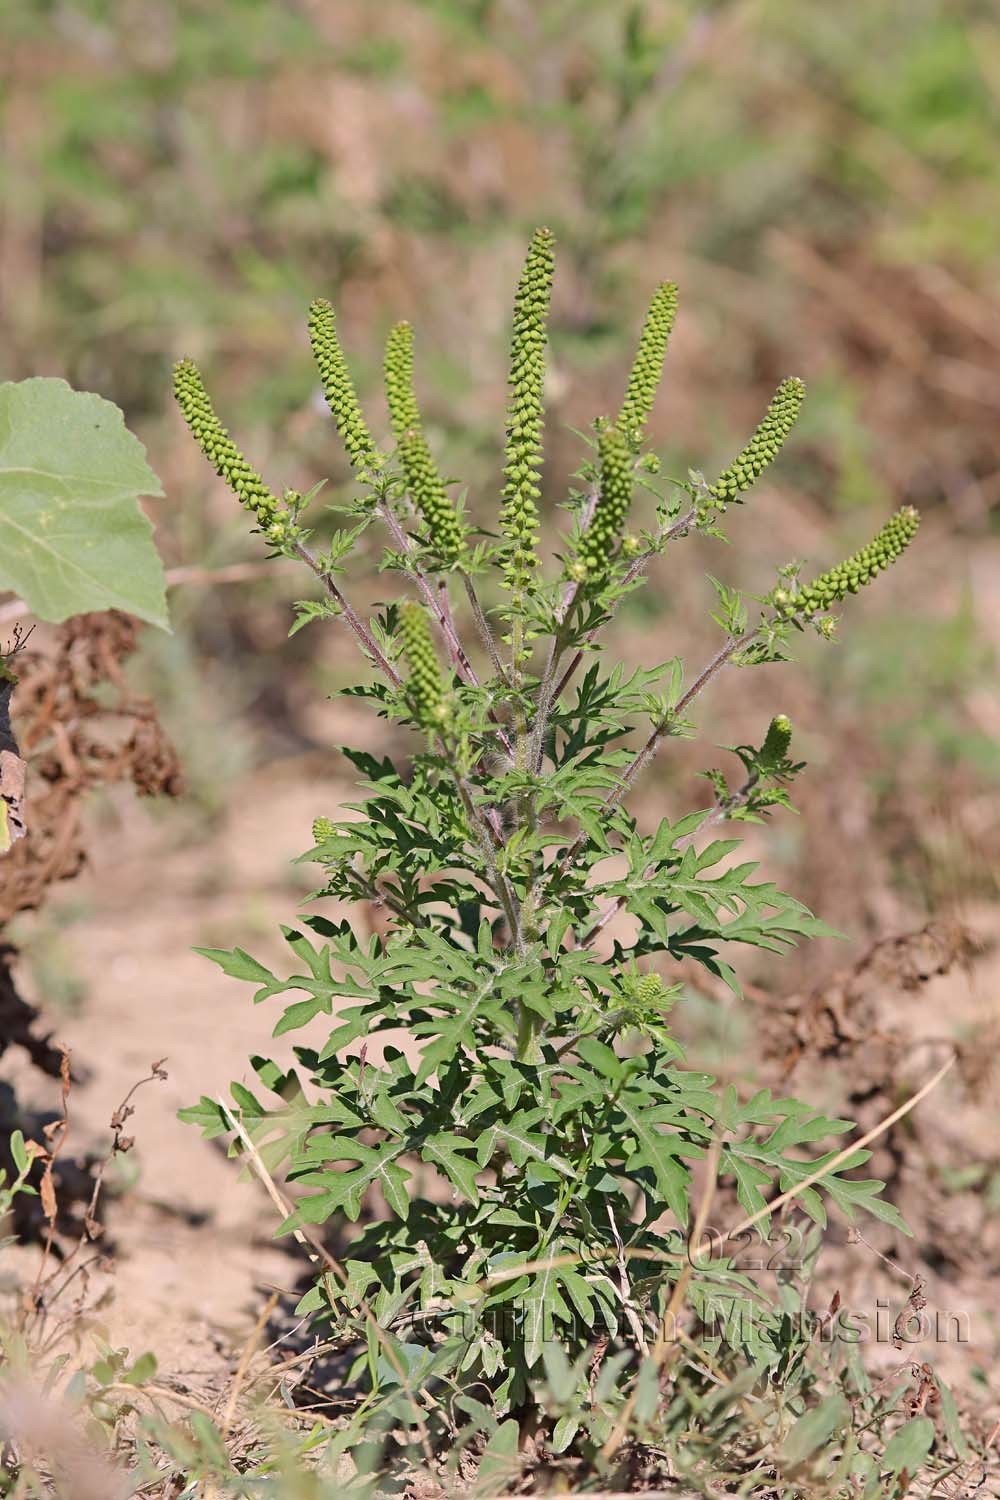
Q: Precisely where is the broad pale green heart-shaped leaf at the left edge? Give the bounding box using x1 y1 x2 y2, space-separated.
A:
0 378 169 630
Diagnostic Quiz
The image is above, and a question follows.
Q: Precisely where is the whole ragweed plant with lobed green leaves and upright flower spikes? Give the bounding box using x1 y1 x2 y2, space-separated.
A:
175 231 916 1473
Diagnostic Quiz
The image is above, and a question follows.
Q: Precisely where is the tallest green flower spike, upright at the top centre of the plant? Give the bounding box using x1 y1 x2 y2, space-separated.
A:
501 230 555 611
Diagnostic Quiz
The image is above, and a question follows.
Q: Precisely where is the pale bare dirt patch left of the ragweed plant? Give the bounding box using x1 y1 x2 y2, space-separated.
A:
6 773 352 1388
